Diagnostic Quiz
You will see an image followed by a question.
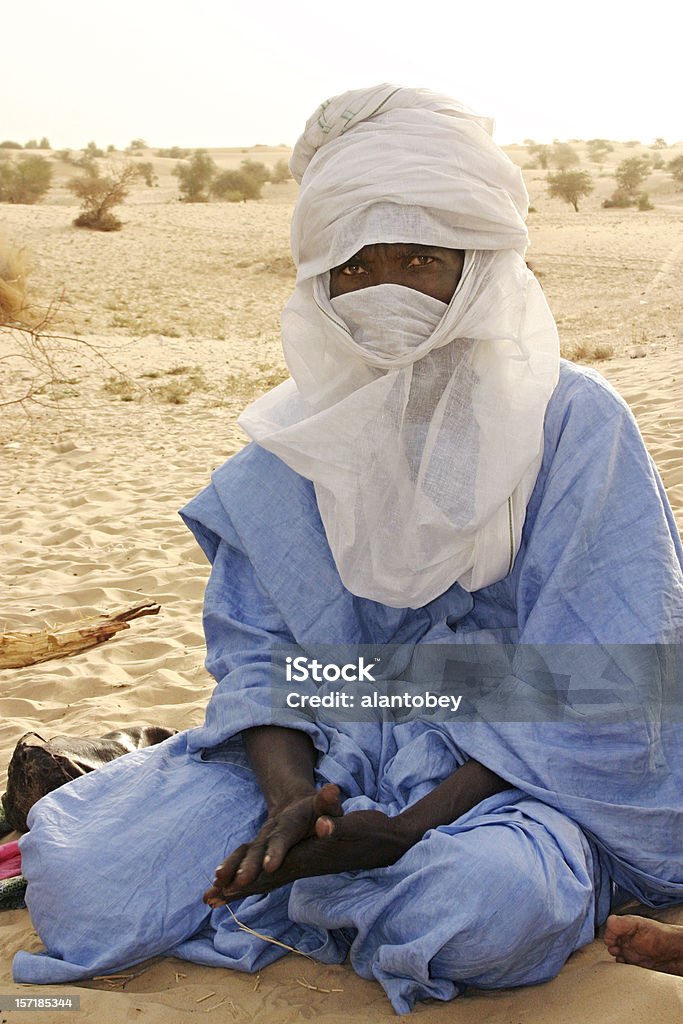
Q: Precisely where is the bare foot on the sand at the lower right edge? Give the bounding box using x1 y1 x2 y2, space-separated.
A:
604 913 683 976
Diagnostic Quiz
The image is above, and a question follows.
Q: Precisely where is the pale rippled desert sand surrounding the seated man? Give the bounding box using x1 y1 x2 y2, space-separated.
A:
0 147 683 1024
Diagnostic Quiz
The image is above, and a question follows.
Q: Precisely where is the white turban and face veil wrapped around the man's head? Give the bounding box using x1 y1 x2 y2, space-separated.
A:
240 85 559 607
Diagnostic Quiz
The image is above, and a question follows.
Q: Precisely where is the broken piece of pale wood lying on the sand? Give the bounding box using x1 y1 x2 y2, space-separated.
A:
0 601 160 669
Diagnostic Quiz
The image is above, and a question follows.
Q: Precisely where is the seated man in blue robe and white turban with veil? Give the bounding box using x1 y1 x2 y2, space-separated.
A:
15 86 683 1013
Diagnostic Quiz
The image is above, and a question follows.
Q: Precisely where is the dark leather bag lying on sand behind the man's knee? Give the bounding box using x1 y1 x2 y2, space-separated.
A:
0 725 177 836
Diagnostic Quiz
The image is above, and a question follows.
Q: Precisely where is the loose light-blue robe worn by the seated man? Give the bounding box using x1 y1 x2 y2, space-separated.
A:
14 364 683 1013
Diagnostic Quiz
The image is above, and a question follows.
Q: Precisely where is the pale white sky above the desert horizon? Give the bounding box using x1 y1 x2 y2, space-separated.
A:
5 0 683 148
